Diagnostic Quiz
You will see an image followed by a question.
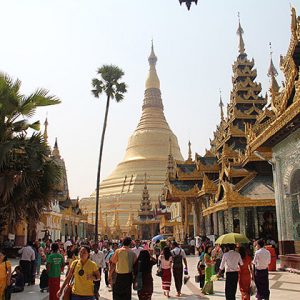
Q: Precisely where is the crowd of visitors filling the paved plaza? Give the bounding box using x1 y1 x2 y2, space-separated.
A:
0 237 276 300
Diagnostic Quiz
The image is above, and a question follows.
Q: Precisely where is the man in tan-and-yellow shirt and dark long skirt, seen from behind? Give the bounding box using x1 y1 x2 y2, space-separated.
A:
110 237 137 300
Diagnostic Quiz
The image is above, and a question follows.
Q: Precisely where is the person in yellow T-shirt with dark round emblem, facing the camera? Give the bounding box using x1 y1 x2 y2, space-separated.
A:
57 245 100 300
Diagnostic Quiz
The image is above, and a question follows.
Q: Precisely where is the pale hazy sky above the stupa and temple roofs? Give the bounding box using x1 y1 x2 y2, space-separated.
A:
0 0 300 198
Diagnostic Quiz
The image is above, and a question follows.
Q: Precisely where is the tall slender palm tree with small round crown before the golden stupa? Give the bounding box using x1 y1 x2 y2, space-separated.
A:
92 65 127 241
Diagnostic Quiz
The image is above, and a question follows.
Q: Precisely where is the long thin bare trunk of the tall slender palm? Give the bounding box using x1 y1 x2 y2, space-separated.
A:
95 96 110 242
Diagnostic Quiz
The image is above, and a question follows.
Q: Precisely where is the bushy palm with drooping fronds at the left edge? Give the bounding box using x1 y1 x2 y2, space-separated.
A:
0 73 60 231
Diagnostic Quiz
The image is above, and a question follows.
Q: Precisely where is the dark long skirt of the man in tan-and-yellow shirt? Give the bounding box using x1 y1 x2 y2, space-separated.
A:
113 273 132 300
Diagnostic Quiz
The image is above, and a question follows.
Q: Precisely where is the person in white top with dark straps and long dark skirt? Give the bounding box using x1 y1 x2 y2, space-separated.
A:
171 241 188 297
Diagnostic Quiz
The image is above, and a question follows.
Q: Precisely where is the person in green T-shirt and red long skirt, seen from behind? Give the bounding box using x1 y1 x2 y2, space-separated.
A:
46 243 64 300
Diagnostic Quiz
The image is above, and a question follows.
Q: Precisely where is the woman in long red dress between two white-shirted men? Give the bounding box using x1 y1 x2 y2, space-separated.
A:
239 247 252 300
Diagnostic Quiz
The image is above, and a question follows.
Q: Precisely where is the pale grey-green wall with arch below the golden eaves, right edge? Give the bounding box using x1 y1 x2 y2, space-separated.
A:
272 129 300 254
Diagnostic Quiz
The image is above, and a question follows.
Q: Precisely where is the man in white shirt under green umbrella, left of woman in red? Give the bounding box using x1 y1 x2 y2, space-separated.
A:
218 244 243 300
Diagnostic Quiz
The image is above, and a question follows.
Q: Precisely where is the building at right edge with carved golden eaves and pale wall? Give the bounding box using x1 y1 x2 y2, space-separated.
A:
243 8 300 270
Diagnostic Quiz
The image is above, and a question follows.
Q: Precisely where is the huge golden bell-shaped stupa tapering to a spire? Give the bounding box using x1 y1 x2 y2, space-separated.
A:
81 43 183 233
